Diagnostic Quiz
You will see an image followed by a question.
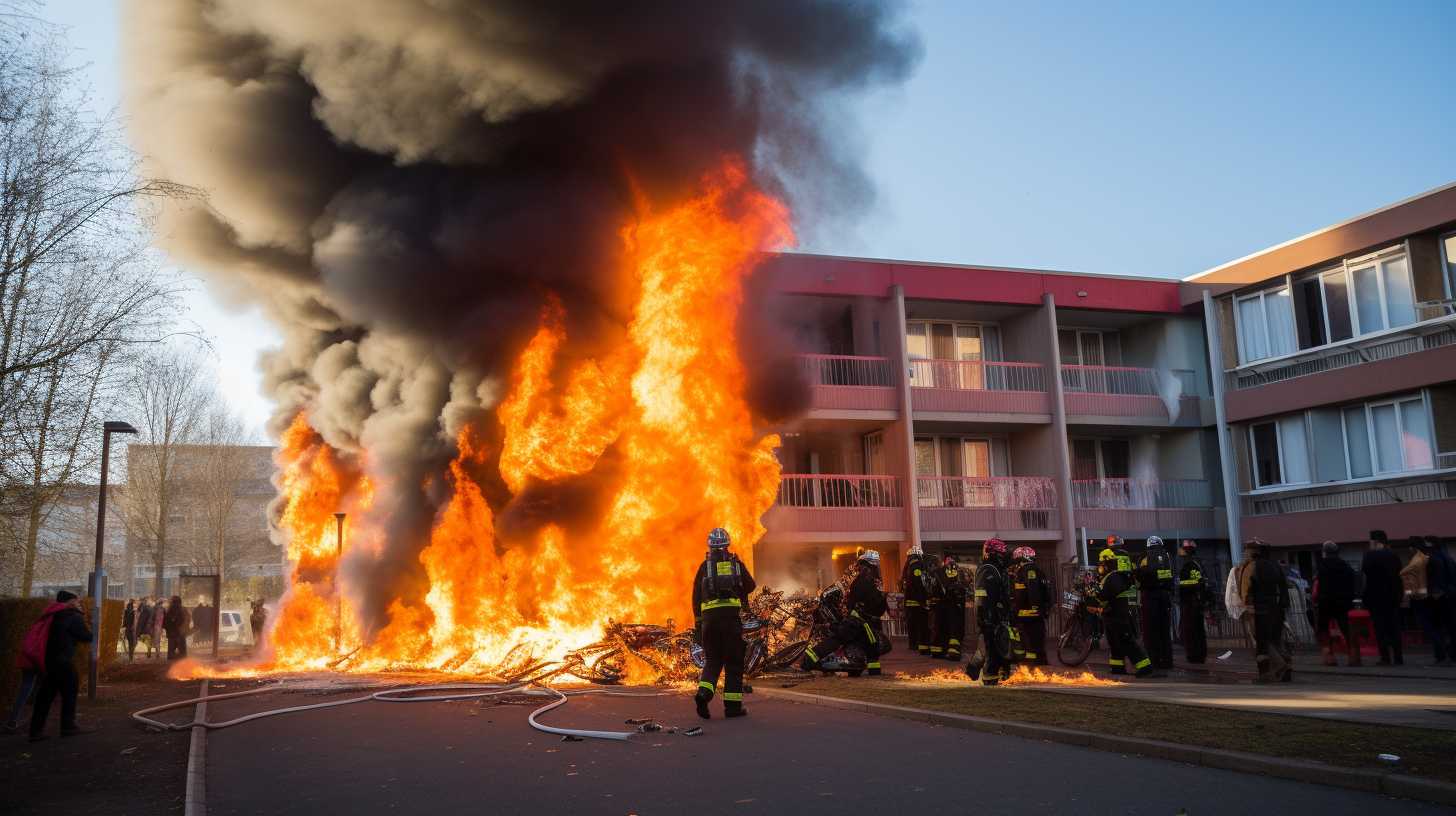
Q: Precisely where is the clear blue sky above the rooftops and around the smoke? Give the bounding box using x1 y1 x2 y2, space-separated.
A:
31 0 1456 424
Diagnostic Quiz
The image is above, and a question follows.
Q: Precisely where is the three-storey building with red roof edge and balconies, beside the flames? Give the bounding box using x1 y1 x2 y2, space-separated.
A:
756 255 1227 586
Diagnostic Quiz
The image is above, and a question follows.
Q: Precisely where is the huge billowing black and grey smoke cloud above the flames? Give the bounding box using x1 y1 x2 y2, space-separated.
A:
124 0 920 632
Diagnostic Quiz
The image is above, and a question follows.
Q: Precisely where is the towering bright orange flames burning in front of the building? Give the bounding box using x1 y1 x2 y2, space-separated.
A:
259 159 792 673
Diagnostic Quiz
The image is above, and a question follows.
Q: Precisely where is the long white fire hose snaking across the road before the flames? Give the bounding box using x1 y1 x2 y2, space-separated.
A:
131 682 665 740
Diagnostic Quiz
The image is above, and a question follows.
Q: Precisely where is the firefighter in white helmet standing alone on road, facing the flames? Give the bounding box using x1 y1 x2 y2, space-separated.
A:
693 527 754 720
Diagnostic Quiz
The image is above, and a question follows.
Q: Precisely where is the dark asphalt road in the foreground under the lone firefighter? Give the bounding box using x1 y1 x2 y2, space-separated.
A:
207 684 1446 816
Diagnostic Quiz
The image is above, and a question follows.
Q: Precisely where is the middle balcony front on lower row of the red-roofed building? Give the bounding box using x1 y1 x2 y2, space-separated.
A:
916 476 1059 538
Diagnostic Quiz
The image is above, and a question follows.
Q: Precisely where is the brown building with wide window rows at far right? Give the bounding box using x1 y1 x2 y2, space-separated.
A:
1184 184 1456 577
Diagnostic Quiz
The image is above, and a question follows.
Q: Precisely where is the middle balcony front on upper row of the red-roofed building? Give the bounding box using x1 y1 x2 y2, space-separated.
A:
910 360 1051 421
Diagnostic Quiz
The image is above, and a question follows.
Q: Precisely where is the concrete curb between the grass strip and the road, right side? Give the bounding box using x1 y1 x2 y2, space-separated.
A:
754 686 1456 806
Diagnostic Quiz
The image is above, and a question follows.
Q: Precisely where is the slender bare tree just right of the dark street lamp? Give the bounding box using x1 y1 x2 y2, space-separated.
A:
122 350 211 595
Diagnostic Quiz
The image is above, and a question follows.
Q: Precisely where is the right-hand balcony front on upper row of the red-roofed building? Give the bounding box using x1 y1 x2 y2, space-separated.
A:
1061 366 1200 425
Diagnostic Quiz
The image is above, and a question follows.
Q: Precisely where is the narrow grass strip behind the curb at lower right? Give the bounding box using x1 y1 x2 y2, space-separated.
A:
785 676 1456 782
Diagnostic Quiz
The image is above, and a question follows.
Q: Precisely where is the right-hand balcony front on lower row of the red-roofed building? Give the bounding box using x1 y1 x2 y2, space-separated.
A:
1072 479 1214 533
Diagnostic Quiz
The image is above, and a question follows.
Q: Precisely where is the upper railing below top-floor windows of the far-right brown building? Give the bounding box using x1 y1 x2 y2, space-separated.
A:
1224 306 1456 391
